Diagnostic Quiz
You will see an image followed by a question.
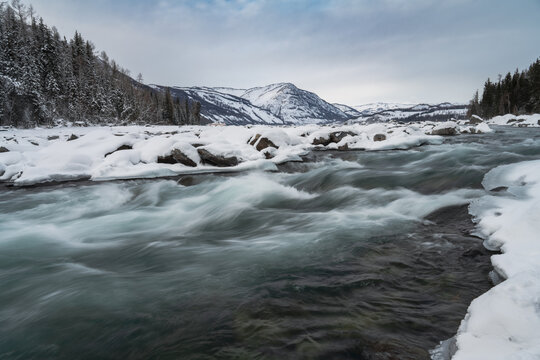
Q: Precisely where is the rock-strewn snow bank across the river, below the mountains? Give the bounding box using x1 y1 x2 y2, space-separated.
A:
0 122 491 185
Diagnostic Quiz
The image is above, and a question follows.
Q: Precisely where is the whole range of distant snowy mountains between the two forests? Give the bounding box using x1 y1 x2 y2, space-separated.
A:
153 83 466 125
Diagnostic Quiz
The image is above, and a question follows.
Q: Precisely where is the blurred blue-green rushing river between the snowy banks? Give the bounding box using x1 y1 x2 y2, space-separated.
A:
0 128 540 359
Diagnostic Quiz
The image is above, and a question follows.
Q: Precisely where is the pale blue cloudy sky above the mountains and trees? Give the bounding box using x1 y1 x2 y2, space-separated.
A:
28 0 540 106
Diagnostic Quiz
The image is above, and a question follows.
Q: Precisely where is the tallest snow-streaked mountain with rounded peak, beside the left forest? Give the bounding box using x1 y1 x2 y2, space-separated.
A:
154 83 350 125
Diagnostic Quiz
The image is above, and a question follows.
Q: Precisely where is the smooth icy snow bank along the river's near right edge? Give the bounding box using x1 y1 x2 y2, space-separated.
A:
453 160 540 360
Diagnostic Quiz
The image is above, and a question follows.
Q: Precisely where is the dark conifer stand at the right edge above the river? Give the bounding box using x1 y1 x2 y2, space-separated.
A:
468 58 540 118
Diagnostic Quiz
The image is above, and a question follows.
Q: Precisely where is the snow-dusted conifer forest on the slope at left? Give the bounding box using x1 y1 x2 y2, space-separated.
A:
0 0 200 127
